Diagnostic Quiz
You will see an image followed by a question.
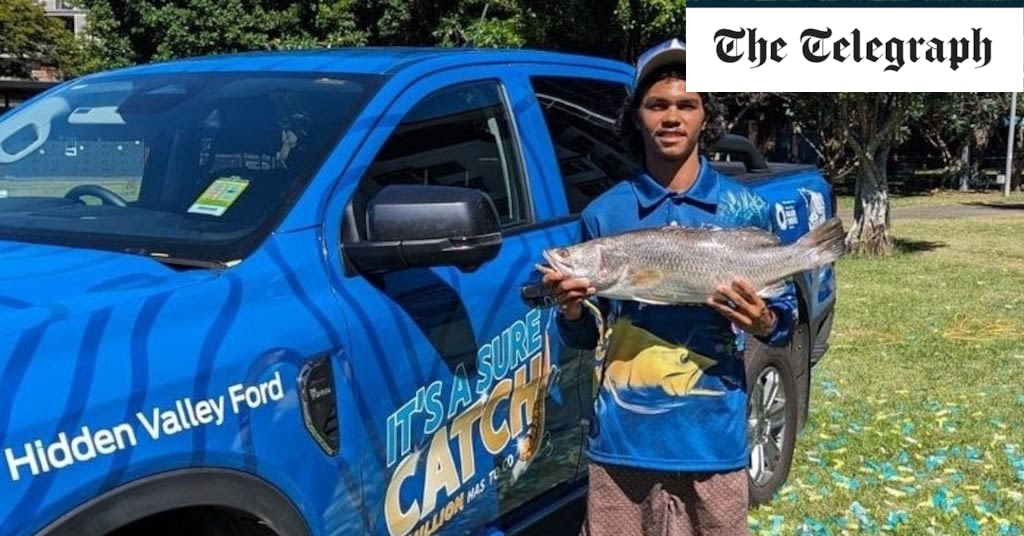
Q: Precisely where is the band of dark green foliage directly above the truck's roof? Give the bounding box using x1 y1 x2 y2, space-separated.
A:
74 0 686 69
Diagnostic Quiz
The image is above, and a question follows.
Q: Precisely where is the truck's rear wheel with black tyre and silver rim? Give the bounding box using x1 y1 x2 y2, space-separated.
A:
744 341 800 505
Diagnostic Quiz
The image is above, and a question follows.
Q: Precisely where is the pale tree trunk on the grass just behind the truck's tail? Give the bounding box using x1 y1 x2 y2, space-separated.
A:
846 148 893 255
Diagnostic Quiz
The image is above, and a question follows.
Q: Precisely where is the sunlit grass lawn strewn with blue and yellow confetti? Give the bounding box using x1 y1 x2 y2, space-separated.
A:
751 216 1024 535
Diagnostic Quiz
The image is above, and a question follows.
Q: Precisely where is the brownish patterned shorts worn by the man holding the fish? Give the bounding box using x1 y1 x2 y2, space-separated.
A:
580 463 750 536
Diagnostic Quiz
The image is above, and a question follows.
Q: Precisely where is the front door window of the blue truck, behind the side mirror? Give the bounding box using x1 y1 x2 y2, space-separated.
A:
353 81 529 229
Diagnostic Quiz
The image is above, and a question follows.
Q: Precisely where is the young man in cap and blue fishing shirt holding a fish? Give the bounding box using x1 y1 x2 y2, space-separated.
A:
544 39 797 536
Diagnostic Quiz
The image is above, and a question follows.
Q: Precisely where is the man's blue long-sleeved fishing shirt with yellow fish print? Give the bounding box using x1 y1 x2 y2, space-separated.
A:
558 157 798 471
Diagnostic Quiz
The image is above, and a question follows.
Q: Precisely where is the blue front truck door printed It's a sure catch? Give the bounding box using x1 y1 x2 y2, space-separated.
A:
332 71 582 536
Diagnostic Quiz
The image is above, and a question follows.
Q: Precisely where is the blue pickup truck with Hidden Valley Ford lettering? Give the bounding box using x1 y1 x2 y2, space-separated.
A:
0 48 835 536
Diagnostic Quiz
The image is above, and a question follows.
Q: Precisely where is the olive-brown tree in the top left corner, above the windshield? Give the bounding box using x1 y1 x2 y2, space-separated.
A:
0 0 82 78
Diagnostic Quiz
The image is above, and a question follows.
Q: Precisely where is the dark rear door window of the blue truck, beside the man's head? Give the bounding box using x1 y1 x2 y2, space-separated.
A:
530 77 638 214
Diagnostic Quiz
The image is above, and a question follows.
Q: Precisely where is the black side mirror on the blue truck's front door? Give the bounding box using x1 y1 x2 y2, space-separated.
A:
344 184 502 274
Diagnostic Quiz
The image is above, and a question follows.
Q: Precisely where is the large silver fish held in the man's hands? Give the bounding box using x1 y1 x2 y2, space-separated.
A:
542 217 845 304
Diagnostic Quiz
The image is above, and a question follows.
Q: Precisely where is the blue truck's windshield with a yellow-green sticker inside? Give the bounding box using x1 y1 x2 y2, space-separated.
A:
0 73 379 261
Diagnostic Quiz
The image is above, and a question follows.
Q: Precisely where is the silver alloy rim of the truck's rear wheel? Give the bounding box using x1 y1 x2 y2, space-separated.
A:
746 366 787 486
